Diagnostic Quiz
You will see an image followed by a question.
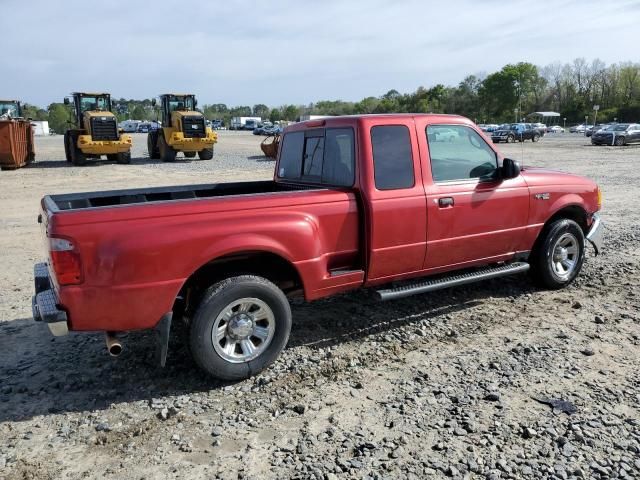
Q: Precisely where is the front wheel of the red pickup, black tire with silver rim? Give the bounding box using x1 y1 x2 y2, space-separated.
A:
529 218 585 290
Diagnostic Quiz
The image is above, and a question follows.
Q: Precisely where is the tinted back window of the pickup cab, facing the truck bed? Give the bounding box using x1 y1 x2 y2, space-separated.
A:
278 128 355 187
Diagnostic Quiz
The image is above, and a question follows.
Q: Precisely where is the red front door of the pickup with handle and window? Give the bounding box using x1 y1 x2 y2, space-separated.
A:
417 120 529 270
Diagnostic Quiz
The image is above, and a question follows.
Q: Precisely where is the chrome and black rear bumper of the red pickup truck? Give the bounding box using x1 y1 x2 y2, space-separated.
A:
31 263 69 337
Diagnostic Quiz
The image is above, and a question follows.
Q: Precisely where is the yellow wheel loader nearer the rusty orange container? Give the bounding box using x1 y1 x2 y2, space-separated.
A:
64 92 131 165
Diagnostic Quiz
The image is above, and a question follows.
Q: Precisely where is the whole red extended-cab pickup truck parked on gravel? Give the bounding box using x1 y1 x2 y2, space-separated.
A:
33 114 602 379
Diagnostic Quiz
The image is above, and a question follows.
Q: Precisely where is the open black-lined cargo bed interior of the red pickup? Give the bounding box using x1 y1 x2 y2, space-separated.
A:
45 180 322 211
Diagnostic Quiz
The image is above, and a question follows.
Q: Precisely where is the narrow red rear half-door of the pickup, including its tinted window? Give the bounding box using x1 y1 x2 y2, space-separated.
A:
360 118 427 283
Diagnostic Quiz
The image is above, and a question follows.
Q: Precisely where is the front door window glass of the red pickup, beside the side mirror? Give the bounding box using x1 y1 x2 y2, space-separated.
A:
426 125 498 182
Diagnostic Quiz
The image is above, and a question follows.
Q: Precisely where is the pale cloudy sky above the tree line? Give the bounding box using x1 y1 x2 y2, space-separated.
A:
5 0 640 106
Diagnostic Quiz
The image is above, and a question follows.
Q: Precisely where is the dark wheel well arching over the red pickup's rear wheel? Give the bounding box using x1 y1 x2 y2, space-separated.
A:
174 252 303 317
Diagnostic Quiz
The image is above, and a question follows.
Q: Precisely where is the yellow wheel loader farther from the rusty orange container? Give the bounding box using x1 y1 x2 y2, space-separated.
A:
147 93 218 162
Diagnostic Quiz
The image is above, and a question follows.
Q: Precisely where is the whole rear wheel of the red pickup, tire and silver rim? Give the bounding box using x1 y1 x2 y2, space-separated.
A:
189 275 291 380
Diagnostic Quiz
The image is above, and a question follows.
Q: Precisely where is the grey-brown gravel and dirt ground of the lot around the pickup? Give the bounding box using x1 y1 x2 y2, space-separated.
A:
0 132 640 480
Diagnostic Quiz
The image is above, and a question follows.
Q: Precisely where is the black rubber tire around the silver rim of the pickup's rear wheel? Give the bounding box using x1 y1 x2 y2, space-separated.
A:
189 275 291 380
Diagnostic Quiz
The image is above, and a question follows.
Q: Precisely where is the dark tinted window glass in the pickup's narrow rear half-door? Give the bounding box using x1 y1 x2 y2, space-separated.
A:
371 125 415 190
